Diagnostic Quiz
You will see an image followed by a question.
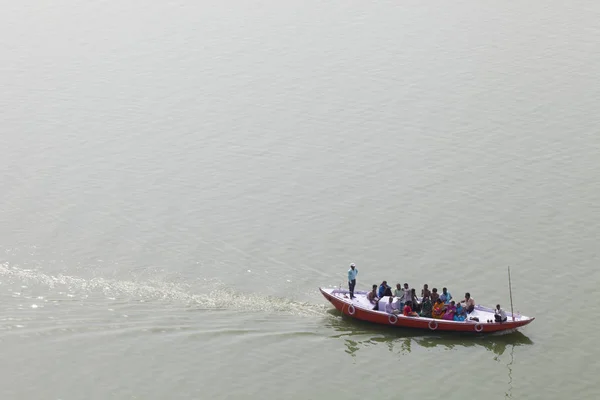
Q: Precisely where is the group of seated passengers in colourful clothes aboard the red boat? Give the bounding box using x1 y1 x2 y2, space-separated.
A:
367 281 507 322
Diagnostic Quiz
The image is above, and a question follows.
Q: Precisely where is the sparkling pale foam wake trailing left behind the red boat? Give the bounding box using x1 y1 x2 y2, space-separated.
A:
0 263 327 316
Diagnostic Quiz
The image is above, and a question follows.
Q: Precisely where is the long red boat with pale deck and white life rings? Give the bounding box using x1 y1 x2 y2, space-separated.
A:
319 288 535 333
